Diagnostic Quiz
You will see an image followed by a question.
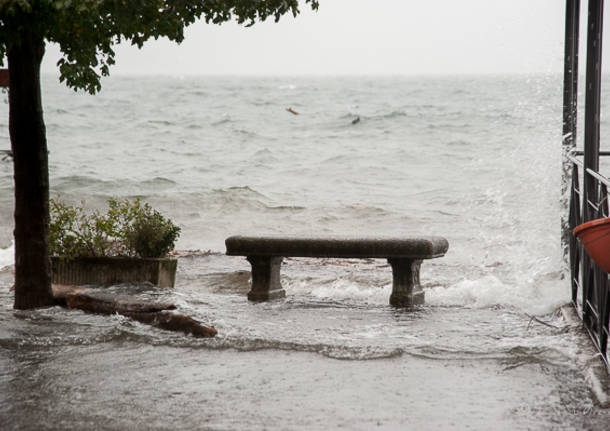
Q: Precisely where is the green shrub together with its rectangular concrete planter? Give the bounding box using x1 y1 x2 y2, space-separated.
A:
49 199 180 286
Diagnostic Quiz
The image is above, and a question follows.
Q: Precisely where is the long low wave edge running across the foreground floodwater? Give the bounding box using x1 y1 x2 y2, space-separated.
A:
0 320 570 369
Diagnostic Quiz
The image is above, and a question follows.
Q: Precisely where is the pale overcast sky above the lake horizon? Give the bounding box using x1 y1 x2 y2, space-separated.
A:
43 0 576 75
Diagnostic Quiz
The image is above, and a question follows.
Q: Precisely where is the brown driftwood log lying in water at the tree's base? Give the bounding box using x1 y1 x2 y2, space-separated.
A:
53 284 216 337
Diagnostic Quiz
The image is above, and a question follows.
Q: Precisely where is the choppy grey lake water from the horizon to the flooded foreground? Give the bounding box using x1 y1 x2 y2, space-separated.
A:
0 76 610 430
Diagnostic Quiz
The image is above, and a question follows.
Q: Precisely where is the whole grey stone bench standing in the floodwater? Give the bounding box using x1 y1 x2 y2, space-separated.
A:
225 236 449 307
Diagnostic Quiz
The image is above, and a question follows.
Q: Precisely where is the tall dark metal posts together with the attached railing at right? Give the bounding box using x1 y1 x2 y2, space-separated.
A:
562 0 610 369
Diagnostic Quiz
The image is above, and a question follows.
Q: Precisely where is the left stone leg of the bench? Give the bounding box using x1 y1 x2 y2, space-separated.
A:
247 256 286 301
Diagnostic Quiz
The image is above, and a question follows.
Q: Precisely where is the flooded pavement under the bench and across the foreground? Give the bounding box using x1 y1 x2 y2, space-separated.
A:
0 255 610 430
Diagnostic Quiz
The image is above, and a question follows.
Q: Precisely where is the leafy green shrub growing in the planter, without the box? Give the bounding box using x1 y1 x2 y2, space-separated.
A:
49 199 180 259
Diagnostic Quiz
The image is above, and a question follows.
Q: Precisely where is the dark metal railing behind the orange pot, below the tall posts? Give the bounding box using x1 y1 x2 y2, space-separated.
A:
568 151 610 369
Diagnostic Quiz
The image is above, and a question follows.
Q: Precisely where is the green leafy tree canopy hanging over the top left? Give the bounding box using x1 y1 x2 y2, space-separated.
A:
0 0 318 94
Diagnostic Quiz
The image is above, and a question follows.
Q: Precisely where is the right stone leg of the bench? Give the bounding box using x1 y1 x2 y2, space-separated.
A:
388 258 424 307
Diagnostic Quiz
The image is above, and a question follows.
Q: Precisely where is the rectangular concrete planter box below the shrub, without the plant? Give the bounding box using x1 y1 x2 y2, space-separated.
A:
51 257 178 287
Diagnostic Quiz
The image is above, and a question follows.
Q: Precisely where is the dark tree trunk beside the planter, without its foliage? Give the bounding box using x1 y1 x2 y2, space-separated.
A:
7 27 54 309
